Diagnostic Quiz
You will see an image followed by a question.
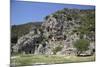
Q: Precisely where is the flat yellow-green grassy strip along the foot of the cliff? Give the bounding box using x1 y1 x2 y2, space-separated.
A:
11 54 95 66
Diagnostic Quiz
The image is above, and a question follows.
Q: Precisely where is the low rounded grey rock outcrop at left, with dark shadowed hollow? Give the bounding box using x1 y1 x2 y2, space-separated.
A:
13 32 50 54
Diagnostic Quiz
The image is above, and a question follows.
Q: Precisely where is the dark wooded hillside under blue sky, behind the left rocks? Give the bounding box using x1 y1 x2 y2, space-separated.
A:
11 22 42 43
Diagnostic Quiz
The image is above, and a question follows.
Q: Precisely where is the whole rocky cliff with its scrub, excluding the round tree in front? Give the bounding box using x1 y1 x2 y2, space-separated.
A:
12 8 95 55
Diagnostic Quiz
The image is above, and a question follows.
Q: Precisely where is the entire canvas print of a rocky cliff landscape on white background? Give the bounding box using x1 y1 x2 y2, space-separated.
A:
10 0 95 67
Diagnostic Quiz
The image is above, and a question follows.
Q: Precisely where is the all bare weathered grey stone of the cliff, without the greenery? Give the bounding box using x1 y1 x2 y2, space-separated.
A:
13 9 95 55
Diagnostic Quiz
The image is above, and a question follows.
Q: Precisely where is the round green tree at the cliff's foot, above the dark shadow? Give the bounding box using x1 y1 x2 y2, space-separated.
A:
74 39 89 55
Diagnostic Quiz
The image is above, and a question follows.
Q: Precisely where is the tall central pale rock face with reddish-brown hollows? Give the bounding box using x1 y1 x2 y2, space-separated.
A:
42 15 79 55
